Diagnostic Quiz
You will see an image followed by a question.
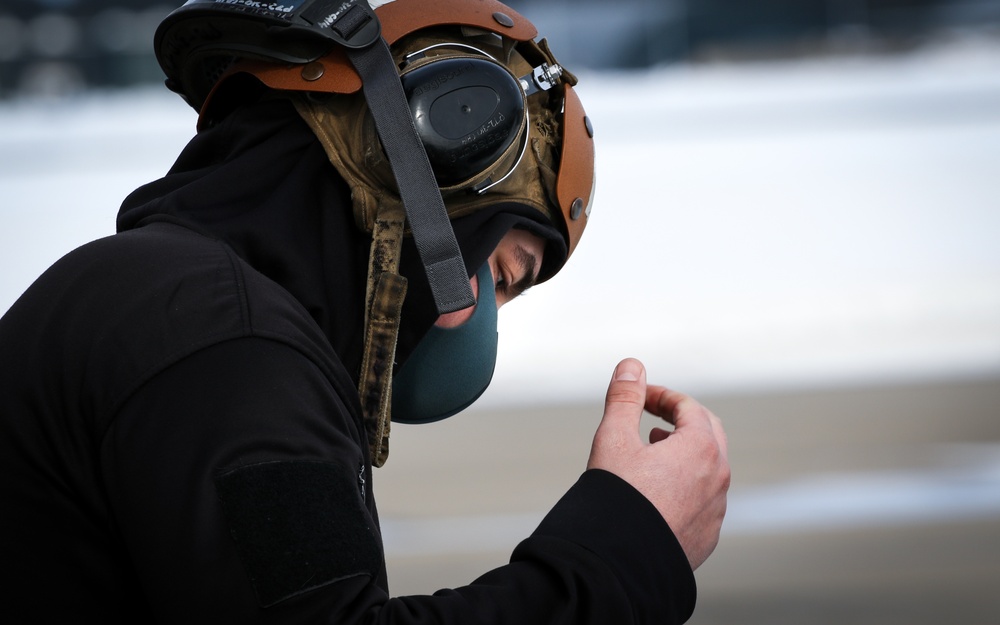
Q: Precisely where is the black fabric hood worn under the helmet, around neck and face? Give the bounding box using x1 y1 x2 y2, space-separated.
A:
118 100 562 381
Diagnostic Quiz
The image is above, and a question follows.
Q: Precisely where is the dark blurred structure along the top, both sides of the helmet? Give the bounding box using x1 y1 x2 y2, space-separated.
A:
0 0 1000 97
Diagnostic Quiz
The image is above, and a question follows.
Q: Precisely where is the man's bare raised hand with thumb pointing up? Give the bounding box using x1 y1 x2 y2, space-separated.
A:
587 359 730 569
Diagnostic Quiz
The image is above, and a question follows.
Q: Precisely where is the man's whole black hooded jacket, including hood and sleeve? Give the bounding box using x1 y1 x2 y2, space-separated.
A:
0 102 694 625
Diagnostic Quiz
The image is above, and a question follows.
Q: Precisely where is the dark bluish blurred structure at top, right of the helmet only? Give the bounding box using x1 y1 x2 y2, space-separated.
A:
507 0 1000 69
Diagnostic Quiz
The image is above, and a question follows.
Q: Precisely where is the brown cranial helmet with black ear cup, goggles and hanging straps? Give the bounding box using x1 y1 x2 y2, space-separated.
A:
154 0 594 465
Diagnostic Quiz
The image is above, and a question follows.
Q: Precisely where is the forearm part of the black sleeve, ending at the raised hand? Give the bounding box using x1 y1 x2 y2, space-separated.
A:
384 470 695 625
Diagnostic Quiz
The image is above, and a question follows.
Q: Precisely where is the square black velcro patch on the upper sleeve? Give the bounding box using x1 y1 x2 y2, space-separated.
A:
215 461 382 608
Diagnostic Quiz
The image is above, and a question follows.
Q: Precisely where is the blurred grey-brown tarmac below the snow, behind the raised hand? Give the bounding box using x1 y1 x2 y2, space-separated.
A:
375 372 1000 625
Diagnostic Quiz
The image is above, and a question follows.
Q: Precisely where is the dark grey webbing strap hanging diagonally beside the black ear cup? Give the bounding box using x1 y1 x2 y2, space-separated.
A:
347 37 476 314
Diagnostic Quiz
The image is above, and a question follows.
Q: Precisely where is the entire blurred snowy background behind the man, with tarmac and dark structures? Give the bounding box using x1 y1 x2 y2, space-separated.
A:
0 0 1000 625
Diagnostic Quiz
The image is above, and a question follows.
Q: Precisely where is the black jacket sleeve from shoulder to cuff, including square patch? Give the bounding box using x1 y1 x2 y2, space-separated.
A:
101 338 694 625
